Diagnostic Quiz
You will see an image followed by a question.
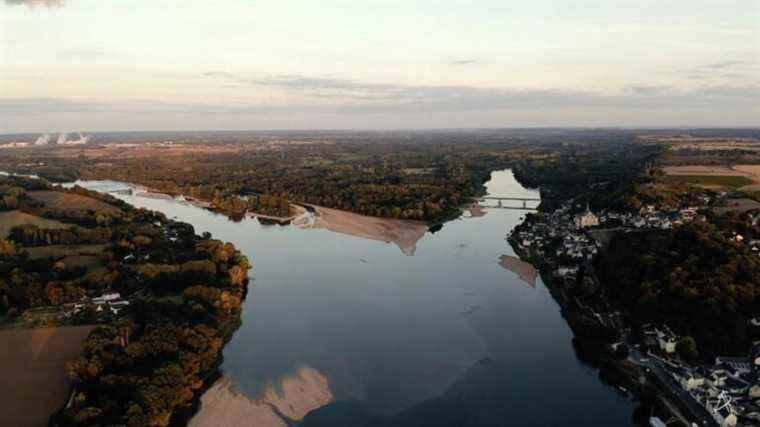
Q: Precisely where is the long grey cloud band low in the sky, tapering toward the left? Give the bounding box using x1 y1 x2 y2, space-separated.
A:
205 71 760 112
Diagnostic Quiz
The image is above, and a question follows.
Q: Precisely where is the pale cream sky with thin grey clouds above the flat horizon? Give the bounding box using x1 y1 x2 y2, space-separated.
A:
0 0 760 133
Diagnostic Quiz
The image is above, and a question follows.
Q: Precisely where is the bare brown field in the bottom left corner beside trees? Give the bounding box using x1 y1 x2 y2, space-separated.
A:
0 326 93 427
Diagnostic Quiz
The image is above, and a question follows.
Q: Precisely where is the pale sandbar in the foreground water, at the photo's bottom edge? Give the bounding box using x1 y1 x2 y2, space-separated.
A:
189 367 333 427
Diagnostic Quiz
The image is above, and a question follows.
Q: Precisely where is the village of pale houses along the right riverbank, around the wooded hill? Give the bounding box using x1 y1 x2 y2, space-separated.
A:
508 193 760 427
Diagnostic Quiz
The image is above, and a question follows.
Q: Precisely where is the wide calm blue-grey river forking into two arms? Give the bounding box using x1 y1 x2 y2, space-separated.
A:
70 170 634 426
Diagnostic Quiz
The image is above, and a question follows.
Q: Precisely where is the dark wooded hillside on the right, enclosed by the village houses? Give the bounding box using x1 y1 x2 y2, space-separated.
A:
595 222 760 359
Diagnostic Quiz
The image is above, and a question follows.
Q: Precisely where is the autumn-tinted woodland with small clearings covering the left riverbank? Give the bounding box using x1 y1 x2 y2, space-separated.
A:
0 177 250 426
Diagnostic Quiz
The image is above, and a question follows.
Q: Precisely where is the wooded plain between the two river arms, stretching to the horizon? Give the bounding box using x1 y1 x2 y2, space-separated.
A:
0 133 588 223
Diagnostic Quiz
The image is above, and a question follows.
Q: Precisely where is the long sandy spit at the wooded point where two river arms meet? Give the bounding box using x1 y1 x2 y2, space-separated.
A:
295 205 428 255
